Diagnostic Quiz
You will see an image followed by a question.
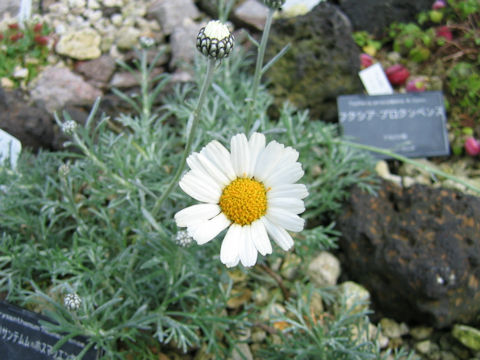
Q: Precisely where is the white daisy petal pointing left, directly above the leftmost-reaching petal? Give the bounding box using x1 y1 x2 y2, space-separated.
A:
179 170 222 204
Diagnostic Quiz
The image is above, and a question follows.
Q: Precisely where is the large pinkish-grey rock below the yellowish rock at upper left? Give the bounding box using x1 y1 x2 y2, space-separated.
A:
31 66 102 112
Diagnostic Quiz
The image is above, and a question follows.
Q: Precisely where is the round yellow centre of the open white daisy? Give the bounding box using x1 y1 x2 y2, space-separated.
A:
219 178 267 225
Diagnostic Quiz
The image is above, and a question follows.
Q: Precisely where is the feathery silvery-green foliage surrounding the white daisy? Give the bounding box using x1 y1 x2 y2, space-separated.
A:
0 29 382 359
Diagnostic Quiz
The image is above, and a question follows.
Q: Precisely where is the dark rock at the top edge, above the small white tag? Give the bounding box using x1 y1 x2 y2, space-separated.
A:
339 0 433 36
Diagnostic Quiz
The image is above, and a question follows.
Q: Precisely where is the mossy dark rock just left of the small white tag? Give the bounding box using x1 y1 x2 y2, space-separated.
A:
266 2 362 122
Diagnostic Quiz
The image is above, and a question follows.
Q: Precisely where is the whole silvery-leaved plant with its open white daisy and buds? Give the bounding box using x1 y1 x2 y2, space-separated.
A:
0 1 414 359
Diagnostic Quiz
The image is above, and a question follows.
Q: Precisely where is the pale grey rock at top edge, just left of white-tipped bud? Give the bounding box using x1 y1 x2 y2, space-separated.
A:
148 0 200 35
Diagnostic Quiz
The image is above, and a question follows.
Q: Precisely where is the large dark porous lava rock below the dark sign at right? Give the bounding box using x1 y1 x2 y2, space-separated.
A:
338 181 480 328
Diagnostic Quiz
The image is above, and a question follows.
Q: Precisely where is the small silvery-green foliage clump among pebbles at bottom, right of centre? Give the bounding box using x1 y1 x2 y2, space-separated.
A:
259 284 416 360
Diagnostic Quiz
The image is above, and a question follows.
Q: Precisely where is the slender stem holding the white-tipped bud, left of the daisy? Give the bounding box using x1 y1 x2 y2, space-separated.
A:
152 59 216 217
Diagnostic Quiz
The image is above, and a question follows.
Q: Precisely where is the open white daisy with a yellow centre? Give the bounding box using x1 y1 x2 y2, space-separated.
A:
175 133 308 267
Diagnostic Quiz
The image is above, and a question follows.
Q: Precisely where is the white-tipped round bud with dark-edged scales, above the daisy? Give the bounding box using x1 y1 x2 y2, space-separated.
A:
197 20 234 60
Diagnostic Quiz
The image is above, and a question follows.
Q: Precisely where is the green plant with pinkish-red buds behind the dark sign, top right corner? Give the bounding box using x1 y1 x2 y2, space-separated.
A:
354 0 480 155
